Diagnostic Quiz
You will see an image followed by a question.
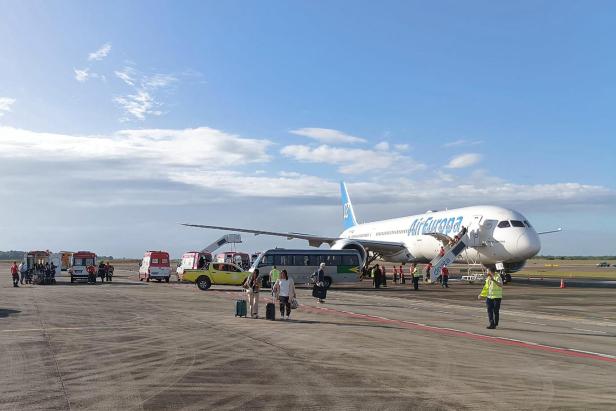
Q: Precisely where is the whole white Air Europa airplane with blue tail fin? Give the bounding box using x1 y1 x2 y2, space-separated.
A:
183 182 561 279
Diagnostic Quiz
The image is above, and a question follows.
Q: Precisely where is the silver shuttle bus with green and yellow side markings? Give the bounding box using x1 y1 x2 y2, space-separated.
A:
249 248 364 288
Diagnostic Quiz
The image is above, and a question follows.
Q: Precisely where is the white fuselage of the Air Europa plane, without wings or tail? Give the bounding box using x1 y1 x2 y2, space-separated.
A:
340 206 541 271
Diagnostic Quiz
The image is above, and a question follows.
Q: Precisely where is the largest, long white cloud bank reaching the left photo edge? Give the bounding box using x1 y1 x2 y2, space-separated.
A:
0 127 271 169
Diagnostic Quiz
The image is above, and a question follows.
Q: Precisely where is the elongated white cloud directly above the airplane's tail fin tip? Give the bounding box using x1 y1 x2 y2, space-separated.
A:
280 145 425 174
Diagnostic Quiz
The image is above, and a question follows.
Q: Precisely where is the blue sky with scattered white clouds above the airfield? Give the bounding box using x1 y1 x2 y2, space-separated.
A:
0 1 616 256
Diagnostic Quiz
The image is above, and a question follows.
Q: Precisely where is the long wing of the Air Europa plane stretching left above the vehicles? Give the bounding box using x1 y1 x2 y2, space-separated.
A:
182 224 406 254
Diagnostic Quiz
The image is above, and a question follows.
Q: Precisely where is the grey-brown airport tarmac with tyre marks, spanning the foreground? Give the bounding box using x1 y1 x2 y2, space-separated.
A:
0 269 616 410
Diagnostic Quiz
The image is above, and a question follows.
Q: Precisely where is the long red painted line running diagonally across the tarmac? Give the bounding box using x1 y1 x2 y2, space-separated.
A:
221 293 616 363
